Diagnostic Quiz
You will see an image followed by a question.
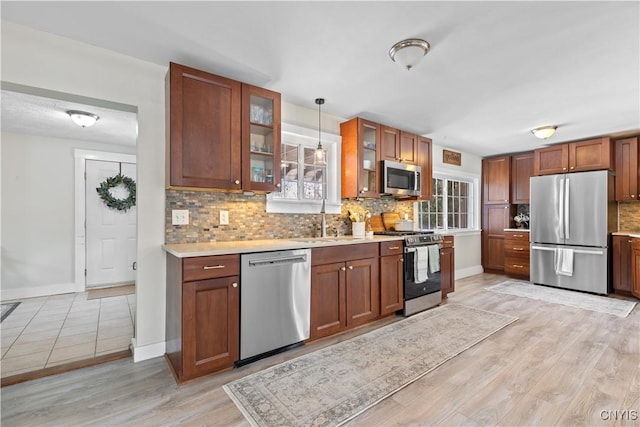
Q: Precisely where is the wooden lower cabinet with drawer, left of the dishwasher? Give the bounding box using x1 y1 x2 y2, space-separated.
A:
166 255 240 382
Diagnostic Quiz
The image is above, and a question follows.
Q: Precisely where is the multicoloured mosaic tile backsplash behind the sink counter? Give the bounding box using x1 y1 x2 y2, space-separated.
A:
165 190 413 243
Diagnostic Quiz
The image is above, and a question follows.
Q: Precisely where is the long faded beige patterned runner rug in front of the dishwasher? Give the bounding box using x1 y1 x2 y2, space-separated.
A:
223 304 517 427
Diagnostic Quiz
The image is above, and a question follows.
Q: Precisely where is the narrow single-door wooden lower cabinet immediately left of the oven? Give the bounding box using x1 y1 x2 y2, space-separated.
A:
380 241 404 316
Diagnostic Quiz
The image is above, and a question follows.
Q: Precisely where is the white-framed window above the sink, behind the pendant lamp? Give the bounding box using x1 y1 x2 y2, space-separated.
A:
267 123 340 214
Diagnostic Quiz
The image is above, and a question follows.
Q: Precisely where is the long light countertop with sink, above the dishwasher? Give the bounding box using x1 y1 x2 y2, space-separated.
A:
162 235 402 258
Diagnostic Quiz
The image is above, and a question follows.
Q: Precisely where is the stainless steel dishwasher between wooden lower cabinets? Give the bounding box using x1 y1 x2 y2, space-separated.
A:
237 249 311 365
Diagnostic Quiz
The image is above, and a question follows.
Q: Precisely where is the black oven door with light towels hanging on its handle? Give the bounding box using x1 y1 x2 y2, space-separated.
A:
404 243 442 301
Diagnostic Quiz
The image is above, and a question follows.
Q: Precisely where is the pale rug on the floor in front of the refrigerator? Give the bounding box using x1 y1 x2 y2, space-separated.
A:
486 280 636 317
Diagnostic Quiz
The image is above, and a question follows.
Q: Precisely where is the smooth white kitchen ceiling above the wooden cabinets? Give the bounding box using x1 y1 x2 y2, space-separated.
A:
0 1 640 156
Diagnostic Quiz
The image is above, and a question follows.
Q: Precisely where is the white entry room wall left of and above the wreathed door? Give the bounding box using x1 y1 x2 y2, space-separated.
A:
0 132 135 300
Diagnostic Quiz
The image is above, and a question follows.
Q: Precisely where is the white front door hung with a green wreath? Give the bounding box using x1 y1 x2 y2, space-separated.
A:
85 160 136 287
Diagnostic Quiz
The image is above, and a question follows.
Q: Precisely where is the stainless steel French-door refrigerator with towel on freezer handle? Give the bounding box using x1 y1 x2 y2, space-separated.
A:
529 171 617 294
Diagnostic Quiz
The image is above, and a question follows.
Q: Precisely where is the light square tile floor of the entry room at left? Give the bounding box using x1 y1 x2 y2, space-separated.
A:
0 292 136 378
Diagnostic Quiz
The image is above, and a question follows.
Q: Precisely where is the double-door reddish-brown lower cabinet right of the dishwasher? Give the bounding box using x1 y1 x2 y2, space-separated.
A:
309 243 380 340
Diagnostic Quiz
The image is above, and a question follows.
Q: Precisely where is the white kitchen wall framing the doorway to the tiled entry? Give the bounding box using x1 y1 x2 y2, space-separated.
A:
1 21 168 360
